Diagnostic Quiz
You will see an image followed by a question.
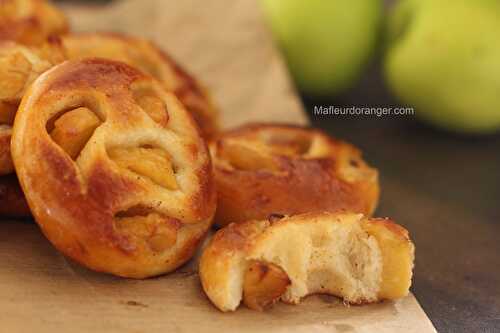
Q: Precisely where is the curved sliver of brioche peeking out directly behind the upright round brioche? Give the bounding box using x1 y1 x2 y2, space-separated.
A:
63 33 218 138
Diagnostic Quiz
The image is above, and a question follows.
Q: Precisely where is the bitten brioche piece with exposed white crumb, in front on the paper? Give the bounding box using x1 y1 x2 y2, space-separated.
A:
199 212 414 311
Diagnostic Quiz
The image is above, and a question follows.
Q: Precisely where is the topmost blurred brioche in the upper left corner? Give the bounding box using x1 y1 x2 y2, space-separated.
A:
0 0 68 45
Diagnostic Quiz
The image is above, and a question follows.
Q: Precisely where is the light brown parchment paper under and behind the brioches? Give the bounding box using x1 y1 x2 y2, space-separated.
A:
0 0 435 333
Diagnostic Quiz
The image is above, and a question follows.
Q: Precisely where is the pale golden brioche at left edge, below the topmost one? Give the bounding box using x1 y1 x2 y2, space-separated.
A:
0 38 65 175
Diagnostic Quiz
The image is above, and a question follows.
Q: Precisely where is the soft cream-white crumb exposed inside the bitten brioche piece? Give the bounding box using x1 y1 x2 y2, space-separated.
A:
248 214 383 303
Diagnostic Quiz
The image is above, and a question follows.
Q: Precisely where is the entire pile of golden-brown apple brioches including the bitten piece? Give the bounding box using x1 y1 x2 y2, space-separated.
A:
0 0 414 311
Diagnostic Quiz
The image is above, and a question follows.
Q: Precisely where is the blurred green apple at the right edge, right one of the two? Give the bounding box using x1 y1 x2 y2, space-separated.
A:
384 0 500 135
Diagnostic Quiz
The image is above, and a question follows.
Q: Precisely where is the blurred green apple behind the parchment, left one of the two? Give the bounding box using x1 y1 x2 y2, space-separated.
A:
261 0 383 97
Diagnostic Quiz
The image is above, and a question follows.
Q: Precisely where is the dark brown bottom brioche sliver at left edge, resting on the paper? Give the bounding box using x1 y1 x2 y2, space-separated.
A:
0 174 31 217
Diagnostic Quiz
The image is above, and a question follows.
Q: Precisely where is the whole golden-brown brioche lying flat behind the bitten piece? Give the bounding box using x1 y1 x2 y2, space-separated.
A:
210 124 379 226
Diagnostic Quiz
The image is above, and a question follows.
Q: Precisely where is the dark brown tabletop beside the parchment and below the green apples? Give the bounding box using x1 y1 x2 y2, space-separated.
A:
58 0 500 332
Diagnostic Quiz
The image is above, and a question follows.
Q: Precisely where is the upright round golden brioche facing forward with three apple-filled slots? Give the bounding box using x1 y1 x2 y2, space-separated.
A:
12 59 216 278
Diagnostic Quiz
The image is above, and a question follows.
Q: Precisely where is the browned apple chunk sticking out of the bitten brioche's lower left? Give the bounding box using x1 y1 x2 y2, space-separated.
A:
243 261 291 311
